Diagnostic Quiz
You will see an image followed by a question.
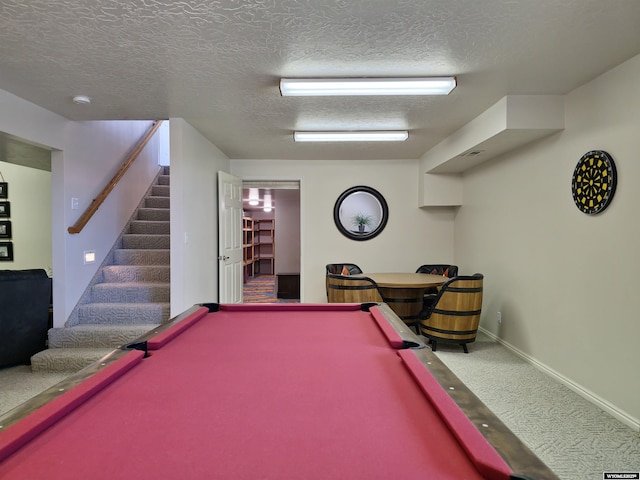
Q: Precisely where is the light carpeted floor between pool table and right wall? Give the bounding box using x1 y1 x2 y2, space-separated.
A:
436 334 640 480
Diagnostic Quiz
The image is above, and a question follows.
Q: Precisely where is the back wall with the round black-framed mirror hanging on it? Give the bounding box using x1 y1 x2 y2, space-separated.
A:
231 160 453 303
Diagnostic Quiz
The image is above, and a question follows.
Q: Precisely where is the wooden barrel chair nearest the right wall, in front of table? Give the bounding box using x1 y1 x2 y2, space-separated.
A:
420 273 484 353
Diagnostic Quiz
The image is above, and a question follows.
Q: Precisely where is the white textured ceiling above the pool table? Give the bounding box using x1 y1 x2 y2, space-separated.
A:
0 0 640 159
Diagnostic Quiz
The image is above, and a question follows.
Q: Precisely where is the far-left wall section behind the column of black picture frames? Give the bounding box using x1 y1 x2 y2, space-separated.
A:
0 160 53 275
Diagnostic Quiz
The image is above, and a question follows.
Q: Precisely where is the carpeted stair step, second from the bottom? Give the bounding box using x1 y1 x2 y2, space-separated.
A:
49 324 156 348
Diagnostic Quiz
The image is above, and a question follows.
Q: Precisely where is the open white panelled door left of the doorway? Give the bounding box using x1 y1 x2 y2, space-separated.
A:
218 172 242 303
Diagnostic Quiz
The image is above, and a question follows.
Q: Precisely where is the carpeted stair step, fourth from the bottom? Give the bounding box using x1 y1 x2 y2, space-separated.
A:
91 282 171 303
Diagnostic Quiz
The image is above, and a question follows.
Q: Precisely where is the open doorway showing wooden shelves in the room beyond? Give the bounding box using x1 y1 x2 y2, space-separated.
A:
242 180 300 303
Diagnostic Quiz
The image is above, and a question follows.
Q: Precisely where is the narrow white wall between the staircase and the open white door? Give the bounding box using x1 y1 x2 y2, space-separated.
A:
170 118 229 316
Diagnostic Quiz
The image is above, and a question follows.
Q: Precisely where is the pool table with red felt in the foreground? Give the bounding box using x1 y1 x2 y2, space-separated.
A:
0 304 556 480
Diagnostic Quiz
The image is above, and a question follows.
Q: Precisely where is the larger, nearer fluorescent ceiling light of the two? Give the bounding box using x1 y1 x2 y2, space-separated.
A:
280 77 456 97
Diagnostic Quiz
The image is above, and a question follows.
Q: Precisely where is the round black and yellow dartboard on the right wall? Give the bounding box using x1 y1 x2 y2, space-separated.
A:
571 150 617 215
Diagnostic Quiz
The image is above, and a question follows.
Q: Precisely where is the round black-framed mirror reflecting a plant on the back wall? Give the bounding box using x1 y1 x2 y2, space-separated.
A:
333 185 389 240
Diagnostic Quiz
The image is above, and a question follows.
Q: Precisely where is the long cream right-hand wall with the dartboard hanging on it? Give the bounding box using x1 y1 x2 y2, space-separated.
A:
455 52 640 428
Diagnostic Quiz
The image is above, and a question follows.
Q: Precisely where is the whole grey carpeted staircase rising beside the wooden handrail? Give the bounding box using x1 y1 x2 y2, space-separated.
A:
31 167 170 372
